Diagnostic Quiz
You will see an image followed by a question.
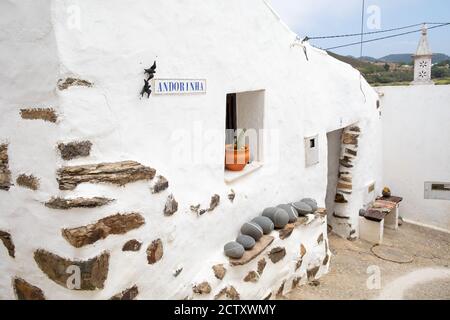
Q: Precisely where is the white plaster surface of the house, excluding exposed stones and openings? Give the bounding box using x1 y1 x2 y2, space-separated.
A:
0 0 382 299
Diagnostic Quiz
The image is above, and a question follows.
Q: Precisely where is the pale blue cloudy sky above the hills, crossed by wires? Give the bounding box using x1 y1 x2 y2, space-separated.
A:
270 0 450 58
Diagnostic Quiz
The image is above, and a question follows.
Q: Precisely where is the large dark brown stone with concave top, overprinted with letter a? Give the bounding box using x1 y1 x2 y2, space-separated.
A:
34 249 109 291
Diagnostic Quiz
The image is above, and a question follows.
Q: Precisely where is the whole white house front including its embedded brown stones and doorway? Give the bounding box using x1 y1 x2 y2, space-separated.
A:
0 0 383 299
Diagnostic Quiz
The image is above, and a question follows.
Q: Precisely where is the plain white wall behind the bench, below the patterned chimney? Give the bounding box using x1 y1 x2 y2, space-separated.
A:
378 86 450 230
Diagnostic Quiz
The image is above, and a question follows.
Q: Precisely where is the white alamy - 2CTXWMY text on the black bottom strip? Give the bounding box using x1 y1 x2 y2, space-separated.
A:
174 304 277 318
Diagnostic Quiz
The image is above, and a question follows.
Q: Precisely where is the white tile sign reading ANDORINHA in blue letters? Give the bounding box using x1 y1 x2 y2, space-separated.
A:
153 79 206 95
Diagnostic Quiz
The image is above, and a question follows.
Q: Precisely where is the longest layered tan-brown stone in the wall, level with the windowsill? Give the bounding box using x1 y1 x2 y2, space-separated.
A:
57 161 156 190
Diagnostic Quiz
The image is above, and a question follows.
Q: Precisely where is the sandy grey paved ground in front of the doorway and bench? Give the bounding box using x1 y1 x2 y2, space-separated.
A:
286 224 450 300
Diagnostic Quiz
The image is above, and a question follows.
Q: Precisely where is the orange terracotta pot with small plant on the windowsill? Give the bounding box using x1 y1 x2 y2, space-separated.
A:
225 129 250 171
